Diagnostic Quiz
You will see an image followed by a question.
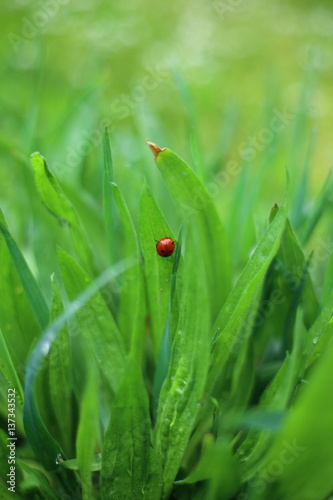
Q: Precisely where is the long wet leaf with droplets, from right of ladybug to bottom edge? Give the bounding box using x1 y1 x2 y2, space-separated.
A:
154 229 210 498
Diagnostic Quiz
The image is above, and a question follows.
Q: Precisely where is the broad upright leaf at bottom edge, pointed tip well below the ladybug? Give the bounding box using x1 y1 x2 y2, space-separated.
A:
101 359 154 500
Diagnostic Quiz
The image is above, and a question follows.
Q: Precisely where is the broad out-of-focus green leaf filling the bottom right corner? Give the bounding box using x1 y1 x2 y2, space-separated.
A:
250 348 333 500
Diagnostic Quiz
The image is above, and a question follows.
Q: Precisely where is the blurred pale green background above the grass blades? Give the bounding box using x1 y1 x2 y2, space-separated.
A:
0 0 333 289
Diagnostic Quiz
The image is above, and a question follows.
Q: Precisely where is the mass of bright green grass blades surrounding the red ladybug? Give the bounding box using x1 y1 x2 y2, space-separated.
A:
0 106 333 500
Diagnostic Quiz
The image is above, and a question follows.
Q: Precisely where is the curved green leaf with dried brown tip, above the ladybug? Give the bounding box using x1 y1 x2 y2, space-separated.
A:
148 143 231 319
